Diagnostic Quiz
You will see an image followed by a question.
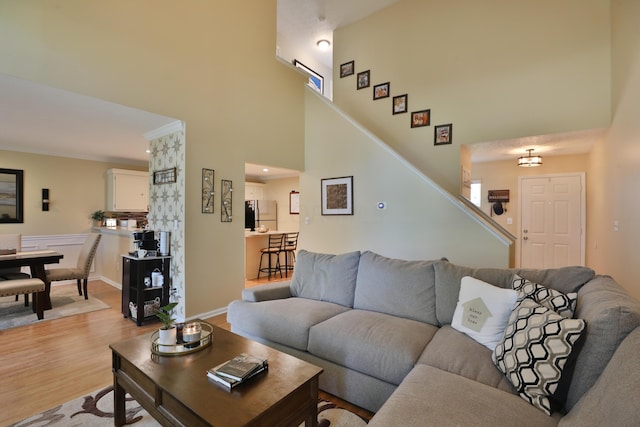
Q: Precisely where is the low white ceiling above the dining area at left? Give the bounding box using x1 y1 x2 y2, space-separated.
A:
0 74 176 166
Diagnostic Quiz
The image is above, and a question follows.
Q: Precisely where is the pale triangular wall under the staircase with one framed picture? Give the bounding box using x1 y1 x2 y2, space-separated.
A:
298 90 509 267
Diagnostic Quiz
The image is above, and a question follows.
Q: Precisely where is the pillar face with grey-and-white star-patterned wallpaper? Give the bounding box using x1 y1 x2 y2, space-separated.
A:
147 129 185 320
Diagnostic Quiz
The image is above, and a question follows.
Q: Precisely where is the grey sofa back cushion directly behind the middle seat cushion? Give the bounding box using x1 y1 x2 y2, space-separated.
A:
353 251 438 325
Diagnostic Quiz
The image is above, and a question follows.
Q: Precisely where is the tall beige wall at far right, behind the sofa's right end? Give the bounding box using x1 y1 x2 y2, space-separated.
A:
587 0 640 298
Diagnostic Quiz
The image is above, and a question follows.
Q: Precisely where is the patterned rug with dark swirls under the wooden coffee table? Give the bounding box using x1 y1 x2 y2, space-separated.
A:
9 386 367 427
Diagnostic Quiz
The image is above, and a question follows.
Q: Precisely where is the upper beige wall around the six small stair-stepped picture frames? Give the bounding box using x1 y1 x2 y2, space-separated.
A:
333 0 610 194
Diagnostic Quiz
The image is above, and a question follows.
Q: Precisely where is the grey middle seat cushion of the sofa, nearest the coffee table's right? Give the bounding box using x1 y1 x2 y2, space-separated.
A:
309 309 438 384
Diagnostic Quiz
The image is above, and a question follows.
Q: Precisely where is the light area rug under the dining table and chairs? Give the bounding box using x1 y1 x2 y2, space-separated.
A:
0 286 109 330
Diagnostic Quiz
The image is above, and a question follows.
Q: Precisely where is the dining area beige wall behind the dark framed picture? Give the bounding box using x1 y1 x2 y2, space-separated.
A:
0 150 145 236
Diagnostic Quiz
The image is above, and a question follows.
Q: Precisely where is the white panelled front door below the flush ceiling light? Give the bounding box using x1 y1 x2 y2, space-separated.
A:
519 173 585 268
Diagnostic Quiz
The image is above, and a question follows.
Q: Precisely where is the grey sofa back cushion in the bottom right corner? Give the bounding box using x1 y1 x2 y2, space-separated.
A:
559 328 640 426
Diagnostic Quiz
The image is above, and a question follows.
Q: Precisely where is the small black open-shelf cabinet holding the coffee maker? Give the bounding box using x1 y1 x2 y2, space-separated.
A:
122 255 171 326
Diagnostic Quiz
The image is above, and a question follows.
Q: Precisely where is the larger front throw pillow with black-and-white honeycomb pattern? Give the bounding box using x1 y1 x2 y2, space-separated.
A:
491 298 586 415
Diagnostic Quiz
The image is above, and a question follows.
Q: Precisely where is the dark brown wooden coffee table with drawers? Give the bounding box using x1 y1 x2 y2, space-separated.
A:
109 326 322 427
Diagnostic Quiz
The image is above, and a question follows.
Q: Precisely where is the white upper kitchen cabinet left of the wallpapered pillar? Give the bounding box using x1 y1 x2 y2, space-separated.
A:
107 169 149 212
